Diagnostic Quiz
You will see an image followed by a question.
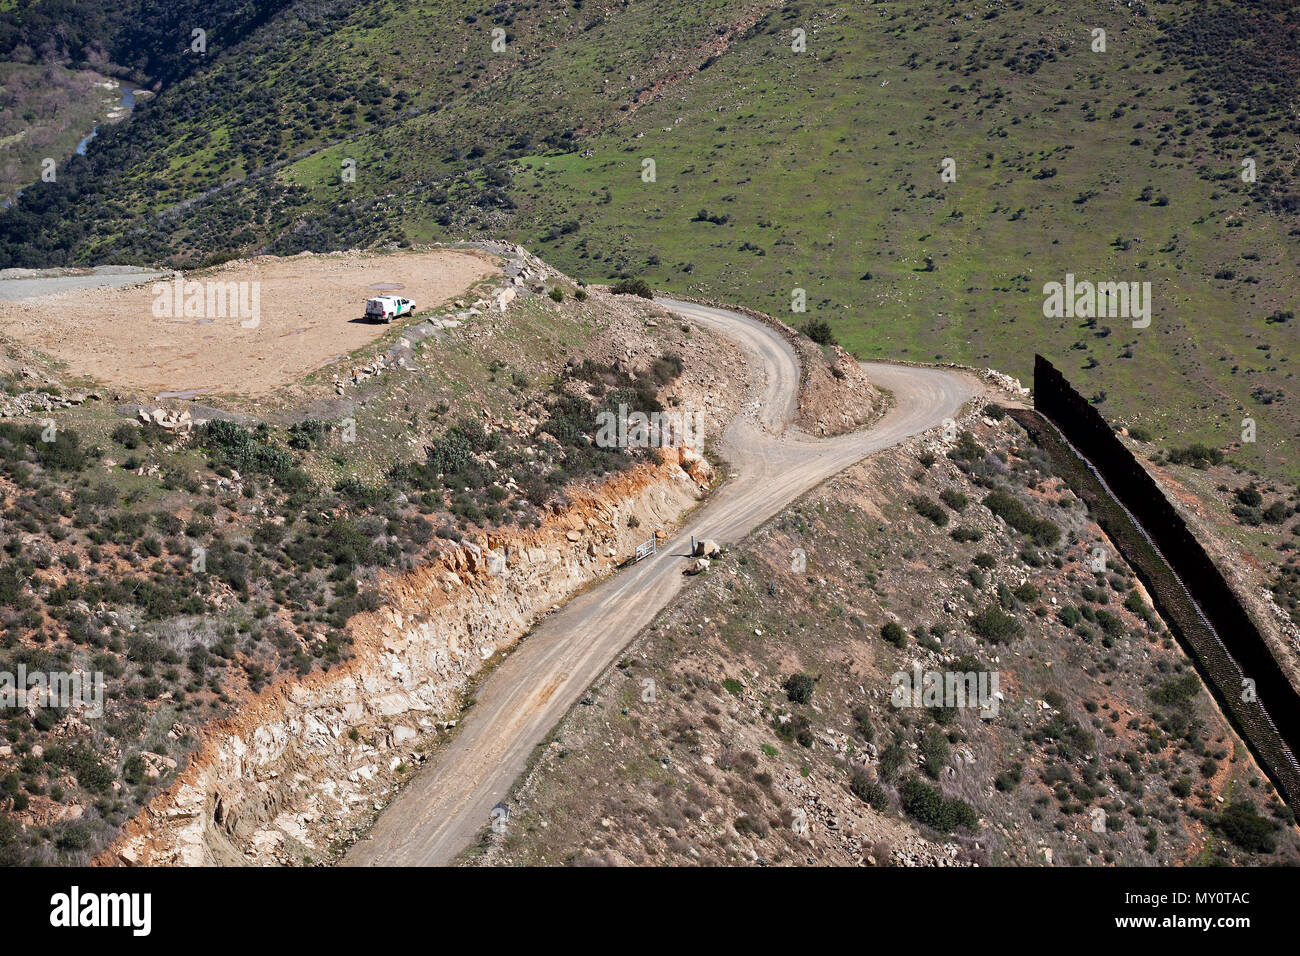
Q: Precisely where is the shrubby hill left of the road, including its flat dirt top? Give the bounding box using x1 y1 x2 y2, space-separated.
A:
0 246 731 865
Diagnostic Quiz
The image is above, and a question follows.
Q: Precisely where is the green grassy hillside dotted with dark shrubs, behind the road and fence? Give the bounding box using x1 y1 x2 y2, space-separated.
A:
0 0 1300 477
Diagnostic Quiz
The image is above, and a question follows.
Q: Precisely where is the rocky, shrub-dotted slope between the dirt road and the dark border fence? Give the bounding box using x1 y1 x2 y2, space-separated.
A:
463 406 1300 866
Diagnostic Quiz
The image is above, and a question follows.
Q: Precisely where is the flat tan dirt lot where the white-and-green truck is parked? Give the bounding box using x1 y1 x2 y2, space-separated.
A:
0 250 498 397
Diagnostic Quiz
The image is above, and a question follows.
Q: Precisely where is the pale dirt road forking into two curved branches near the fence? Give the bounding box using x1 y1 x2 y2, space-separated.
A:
343 299 980 866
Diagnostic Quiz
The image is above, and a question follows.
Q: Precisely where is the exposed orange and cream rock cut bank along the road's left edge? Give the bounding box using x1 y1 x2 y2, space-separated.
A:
95 449 712 865
